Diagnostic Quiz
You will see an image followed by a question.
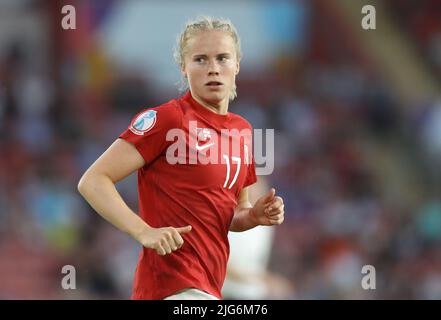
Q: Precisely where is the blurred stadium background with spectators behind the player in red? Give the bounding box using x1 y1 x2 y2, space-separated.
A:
0 0 441 299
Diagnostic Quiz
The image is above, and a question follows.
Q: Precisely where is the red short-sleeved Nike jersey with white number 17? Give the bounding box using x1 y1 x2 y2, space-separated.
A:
120 92 256 299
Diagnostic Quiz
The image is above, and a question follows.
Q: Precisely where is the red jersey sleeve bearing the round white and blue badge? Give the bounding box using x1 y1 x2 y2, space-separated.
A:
119 104 182 163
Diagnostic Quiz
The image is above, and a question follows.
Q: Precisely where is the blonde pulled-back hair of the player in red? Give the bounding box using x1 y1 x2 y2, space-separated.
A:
174 16 242 101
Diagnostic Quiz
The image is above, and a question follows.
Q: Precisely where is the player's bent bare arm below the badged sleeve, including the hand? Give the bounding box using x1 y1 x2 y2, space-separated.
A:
78 139 191 255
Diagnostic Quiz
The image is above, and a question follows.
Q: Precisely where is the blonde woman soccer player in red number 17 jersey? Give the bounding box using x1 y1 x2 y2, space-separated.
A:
78 17 284 299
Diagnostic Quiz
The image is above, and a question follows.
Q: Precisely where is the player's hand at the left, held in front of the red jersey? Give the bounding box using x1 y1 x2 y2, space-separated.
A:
138 226 191 256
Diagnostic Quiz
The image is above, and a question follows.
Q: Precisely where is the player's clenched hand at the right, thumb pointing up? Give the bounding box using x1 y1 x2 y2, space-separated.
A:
250 188 285 226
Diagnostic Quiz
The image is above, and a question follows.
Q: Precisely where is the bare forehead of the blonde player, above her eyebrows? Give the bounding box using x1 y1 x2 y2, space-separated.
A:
187 31 235 55
